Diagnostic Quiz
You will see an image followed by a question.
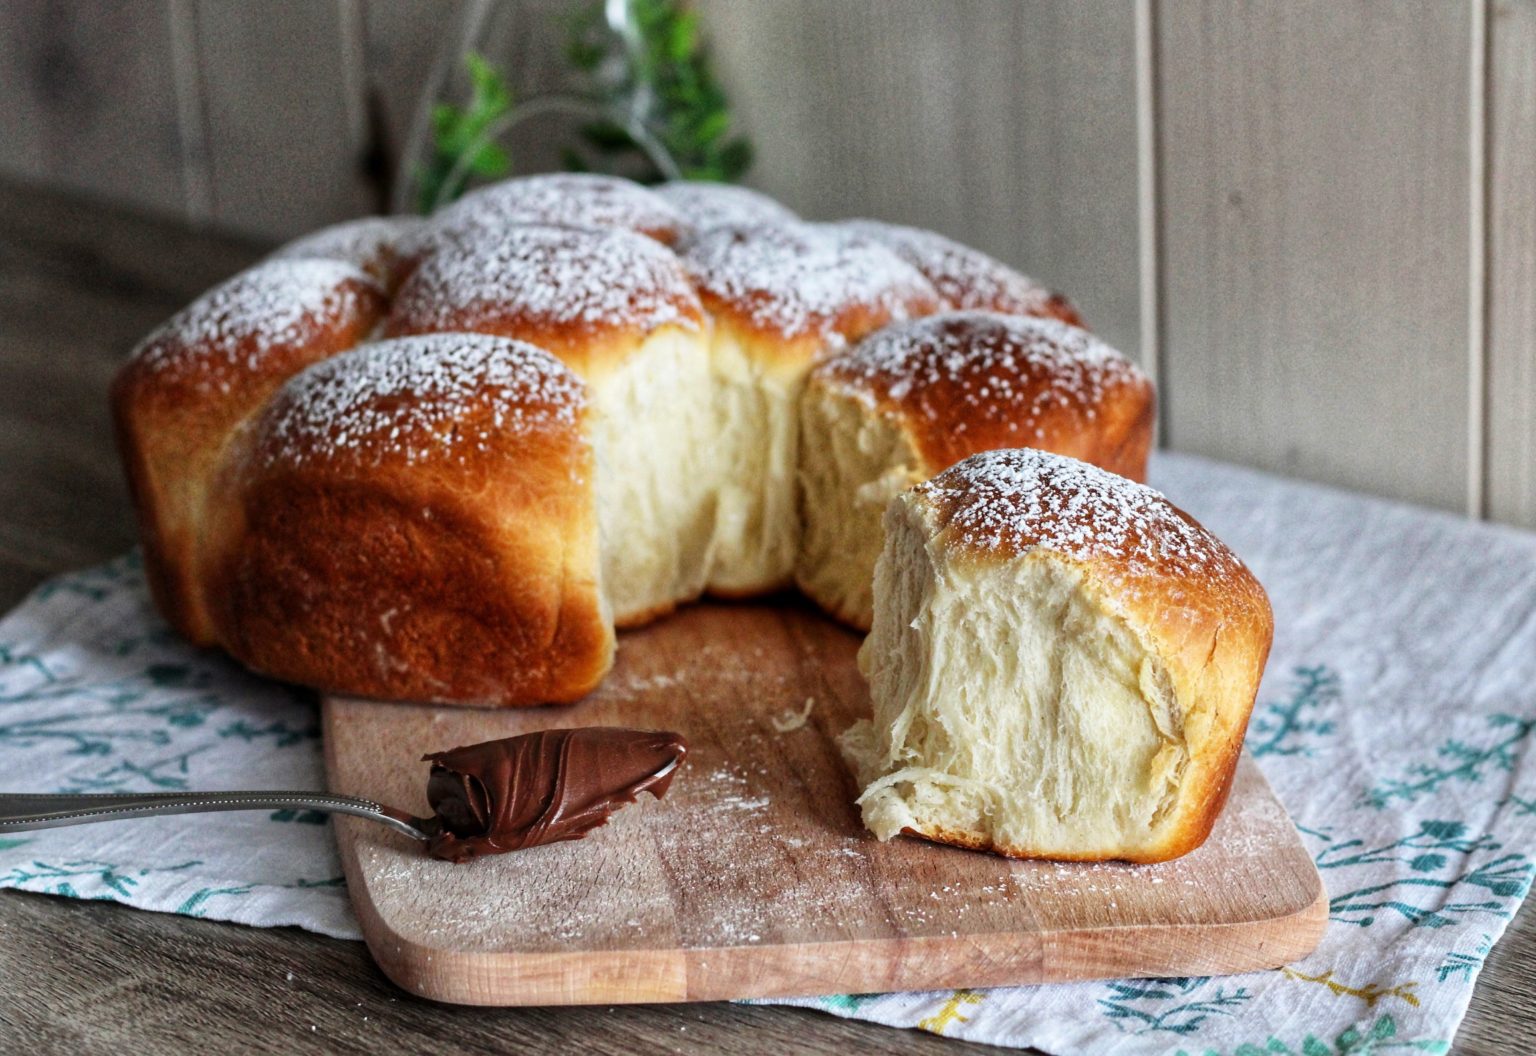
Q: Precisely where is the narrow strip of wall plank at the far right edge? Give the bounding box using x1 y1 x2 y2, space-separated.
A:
1485 0 1536 528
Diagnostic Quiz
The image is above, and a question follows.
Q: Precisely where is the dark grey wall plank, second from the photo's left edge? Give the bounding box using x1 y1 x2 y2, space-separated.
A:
197 0 376 239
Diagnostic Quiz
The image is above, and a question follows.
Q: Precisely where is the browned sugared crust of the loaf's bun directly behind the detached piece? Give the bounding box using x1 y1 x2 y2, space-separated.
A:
811 312 1155 480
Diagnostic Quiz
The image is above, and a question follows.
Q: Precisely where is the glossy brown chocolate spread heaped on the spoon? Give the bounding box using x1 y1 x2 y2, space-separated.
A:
422 726 688 861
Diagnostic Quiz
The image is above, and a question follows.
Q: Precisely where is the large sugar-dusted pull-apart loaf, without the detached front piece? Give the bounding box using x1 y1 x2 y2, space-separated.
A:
114 175 1161 705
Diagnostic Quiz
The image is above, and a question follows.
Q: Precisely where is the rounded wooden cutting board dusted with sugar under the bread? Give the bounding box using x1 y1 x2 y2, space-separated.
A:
324 603 1327 1005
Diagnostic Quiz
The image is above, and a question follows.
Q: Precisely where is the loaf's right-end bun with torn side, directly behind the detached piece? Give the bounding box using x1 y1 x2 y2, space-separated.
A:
796 312 1155 629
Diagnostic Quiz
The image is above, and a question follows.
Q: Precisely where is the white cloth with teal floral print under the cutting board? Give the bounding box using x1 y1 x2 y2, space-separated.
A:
0 454 1536 1056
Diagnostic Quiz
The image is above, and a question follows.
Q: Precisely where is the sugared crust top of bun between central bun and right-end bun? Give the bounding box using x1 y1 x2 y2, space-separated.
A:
684 223 942 370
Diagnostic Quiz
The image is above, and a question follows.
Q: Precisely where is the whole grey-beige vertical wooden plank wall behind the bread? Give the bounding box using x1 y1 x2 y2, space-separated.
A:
0 0 1536 526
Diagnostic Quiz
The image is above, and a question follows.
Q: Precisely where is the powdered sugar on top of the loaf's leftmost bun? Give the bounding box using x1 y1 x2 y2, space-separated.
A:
134 259 375 382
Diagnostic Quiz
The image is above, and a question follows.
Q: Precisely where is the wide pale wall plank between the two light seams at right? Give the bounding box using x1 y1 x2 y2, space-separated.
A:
1157 0 1470 510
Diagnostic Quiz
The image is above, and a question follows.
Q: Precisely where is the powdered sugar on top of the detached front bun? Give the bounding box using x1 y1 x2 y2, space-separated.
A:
914 450 1238 577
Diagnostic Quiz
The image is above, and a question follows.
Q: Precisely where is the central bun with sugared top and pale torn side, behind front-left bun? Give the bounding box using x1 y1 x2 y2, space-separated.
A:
387 217 716 626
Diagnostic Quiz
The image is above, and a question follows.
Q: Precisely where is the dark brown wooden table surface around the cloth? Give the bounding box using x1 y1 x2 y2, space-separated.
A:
0 177 1536 1056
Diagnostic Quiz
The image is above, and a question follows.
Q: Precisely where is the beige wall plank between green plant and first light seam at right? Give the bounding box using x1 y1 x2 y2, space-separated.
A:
700 0 1140 355
